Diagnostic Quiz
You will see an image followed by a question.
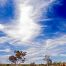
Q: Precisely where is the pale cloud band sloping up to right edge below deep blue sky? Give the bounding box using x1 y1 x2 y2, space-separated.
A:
46 35 66 48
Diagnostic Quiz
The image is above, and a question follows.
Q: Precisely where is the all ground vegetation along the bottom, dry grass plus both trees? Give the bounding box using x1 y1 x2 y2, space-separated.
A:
0 51 66 66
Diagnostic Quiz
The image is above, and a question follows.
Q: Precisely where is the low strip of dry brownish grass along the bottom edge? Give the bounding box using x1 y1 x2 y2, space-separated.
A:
0 63 66 66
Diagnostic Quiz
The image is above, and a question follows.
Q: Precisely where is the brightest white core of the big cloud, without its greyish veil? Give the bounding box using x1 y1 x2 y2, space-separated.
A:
5 0 40 42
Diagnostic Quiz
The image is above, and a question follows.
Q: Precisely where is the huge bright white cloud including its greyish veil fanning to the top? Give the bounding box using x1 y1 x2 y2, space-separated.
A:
2 0 53 43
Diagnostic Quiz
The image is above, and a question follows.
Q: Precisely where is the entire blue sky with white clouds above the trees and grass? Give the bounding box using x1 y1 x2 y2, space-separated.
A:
0 0 66 63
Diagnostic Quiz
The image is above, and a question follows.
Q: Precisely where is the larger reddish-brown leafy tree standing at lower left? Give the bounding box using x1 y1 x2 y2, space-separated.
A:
9 51 26 64
